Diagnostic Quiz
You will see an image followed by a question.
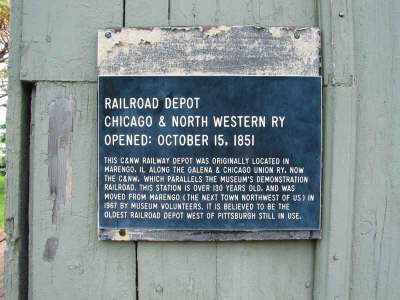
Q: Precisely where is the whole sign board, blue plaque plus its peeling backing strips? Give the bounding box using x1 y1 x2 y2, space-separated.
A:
98 26 321 241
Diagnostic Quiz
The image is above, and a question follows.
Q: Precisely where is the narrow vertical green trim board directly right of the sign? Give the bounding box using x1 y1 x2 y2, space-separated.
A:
314 0 357 300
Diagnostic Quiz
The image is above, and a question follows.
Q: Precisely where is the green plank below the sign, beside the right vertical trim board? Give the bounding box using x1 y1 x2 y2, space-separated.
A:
217 241 314 300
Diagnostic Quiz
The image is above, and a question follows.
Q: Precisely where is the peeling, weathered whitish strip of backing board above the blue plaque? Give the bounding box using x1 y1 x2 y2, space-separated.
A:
97 26 320 76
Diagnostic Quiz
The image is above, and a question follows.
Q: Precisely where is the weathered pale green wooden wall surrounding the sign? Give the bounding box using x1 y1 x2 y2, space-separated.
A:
6 0 400 300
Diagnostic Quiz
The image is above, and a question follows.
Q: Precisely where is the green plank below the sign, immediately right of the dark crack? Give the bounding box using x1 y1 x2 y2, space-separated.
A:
138 242 217 300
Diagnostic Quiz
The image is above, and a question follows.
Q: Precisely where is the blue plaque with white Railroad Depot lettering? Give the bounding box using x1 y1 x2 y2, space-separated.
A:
98 76 321 231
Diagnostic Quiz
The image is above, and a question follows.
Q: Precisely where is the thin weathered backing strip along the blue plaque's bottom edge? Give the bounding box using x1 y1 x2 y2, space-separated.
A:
98 228 321 242
